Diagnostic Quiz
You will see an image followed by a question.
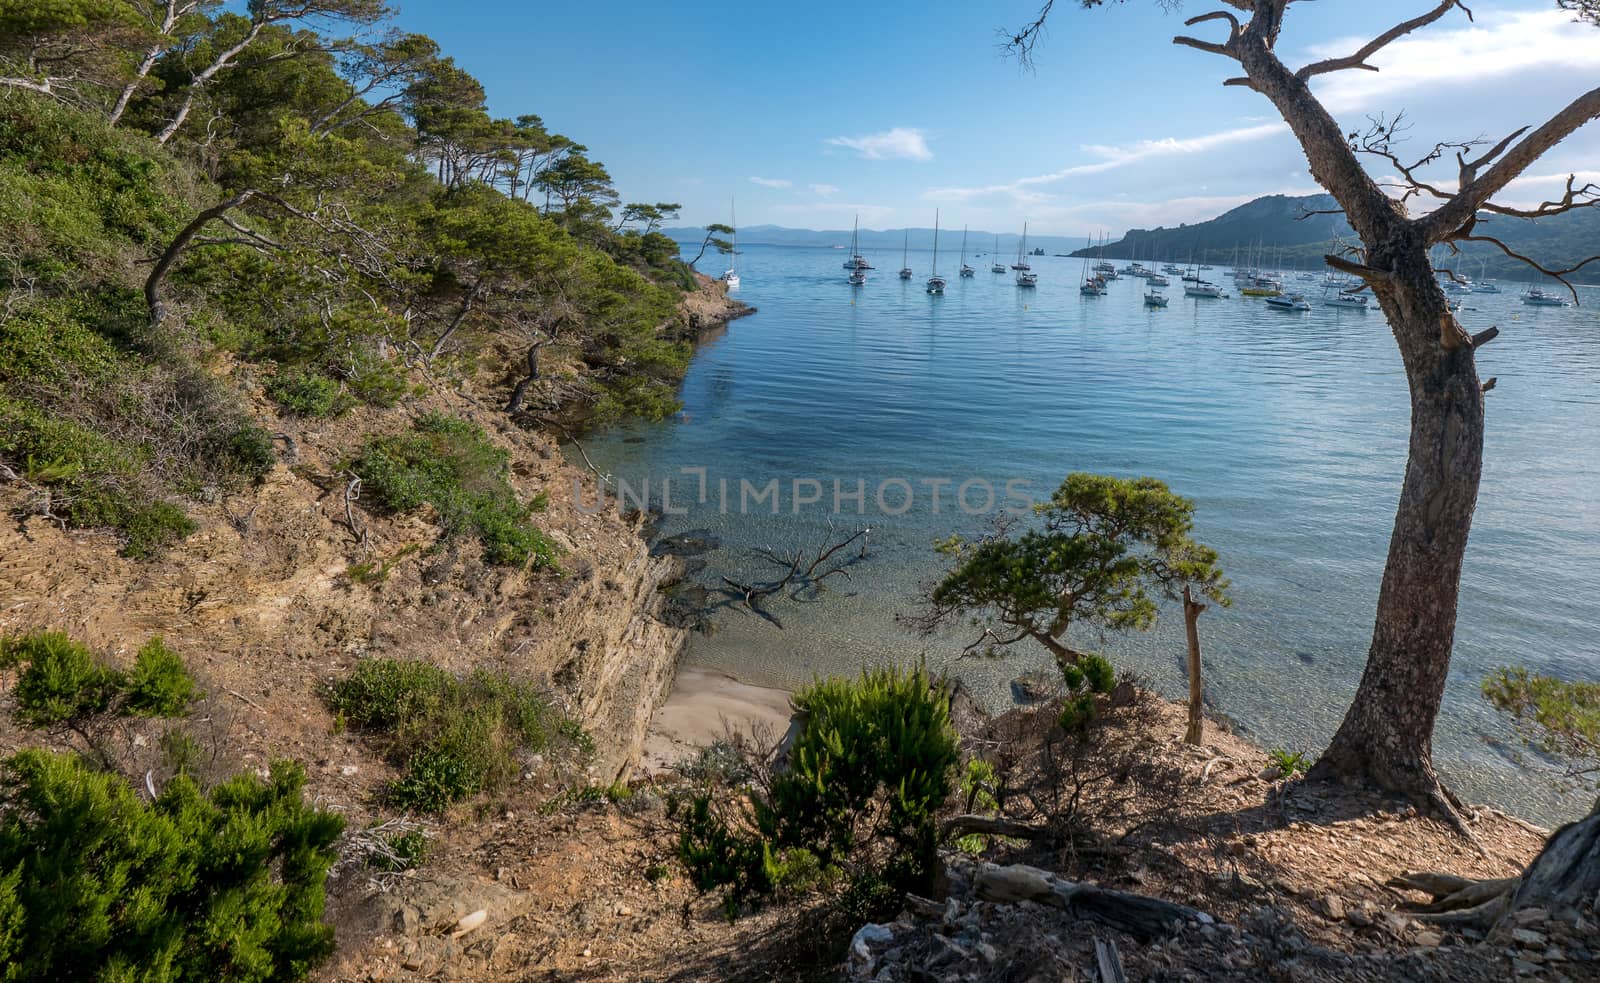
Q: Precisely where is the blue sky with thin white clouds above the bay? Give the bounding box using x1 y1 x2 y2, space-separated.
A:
387 0 1600 235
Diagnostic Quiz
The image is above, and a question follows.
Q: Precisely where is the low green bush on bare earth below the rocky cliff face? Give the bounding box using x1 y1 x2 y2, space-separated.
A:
328 660 592 812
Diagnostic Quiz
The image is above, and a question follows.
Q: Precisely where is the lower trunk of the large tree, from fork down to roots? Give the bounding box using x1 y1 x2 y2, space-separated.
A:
1312 239 1483 816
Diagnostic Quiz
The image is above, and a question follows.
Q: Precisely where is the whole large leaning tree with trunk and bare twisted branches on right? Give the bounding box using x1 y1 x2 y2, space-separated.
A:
1010 0 1600 928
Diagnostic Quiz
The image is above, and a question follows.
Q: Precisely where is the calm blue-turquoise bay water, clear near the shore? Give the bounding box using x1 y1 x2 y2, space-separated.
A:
584 247 1600 820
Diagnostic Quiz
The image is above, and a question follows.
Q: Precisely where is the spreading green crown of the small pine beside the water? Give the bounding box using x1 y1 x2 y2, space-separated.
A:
917 472 1230 682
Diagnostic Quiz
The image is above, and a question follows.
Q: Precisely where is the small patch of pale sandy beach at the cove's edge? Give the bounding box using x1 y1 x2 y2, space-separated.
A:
640 666 792 775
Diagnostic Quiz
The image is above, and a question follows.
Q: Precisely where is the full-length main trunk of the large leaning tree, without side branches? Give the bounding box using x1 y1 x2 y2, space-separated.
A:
1234 23 1483 813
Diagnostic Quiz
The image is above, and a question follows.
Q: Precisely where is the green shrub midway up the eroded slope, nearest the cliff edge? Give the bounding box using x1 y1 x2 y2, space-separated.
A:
350 413 557 567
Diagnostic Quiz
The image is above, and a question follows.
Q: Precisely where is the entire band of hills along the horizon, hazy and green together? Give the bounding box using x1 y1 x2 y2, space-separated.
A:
664 195 1600 283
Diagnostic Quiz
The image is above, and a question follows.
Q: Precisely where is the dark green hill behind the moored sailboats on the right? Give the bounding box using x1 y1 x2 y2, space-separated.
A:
1072 195 1600 283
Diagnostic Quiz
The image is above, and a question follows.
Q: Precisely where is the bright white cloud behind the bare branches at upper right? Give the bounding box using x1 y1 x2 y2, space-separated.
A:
1307 10 1600 112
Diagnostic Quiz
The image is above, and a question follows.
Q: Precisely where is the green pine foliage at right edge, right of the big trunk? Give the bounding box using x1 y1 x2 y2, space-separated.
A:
1483 666 1600 775
